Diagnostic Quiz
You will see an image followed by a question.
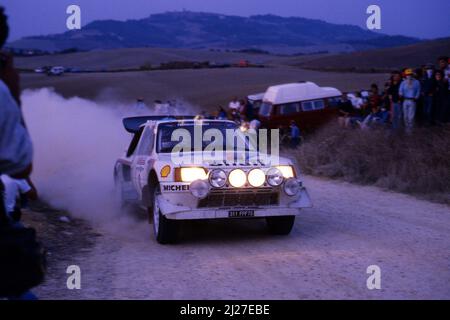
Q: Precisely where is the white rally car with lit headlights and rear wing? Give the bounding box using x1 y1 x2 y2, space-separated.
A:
114 116 312 244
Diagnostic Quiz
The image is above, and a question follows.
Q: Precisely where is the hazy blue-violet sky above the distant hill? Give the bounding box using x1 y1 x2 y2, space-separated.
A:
0 0 450 41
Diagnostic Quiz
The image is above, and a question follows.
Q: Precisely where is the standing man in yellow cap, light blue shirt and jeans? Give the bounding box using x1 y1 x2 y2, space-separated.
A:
399 69 420 132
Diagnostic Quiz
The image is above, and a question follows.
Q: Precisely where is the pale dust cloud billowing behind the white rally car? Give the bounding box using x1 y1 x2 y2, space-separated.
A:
22 88 149 224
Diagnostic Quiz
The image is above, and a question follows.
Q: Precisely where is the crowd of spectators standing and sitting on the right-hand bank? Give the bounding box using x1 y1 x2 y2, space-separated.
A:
339 56 450 132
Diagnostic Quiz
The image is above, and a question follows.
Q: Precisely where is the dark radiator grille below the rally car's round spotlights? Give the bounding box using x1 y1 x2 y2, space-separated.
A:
198 190 279 208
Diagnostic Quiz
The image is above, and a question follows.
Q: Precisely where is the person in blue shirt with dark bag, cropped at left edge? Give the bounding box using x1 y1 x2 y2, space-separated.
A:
0 7 45 299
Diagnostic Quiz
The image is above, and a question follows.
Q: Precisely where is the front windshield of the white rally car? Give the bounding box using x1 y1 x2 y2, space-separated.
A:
156 121 255 153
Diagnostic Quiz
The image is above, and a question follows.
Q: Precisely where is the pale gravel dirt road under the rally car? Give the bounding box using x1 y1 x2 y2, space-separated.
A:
32 177 450 299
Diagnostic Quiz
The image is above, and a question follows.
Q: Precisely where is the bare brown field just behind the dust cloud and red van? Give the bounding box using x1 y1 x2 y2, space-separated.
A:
22 66 387 110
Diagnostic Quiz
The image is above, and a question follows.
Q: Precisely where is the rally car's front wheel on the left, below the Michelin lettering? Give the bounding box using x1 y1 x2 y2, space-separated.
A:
149 186 179 244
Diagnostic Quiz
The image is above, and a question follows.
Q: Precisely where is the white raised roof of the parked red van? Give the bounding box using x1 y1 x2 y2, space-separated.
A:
264 82 342 104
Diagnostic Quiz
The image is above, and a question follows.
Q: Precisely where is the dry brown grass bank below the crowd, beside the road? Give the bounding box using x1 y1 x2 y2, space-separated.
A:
297 125 450 203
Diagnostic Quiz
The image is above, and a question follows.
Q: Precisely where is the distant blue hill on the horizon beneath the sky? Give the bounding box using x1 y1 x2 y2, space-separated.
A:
9 11 419 53
